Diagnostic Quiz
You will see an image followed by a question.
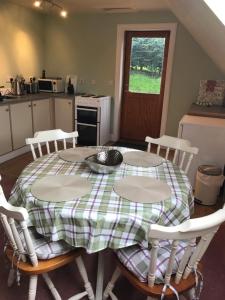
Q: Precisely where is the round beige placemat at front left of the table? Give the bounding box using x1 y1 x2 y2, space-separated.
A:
31 175 92 202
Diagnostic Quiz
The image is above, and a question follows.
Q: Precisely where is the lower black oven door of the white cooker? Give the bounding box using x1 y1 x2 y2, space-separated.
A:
75 121 99 146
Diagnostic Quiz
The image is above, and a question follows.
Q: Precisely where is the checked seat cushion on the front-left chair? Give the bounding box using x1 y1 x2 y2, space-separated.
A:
20 227 74 259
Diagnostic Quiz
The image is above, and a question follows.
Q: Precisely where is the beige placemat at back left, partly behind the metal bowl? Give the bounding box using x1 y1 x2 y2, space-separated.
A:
59 147 98 162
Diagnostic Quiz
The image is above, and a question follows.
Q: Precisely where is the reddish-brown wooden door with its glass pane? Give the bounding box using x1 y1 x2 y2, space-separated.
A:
120 31 170 141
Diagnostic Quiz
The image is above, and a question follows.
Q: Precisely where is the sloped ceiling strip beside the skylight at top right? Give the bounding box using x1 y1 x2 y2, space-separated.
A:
167 0 225 73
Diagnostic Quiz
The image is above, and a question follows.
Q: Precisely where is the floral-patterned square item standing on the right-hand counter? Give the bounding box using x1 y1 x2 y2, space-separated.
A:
196 80 225 105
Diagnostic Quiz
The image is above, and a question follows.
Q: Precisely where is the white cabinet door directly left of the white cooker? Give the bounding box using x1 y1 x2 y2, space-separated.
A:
55 98 74 132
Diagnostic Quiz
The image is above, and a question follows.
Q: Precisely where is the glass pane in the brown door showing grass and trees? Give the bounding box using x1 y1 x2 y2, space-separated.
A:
129 37 166 94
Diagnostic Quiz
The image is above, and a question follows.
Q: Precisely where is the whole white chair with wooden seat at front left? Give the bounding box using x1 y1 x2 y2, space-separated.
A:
0 186 94 300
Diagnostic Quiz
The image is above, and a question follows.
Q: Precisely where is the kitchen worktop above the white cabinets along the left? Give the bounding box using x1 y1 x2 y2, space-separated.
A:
0 92 76 106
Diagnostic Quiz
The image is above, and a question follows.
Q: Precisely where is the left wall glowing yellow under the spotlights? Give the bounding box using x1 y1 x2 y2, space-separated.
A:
0 0 44 86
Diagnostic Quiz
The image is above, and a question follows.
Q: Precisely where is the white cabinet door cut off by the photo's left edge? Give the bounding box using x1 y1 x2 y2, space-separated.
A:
0 105 12 155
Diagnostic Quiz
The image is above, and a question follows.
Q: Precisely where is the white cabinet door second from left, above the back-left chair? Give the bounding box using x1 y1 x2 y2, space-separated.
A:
10 101 33 150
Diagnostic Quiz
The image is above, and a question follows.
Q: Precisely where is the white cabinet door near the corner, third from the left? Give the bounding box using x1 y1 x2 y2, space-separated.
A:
32 98 53 133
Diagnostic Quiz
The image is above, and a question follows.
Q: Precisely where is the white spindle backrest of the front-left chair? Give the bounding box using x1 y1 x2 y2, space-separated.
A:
0 186 38 266
